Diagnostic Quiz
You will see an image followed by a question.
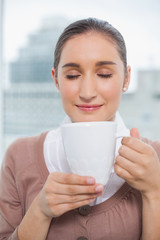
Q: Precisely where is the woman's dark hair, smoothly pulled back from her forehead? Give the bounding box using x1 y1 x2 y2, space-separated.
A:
54 18 127 77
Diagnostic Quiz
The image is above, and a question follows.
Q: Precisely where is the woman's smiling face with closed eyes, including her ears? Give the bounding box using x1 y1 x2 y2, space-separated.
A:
52 32 130 122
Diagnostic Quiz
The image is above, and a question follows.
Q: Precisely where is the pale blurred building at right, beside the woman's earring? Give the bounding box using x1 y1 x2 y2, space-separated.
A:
120 69 160 139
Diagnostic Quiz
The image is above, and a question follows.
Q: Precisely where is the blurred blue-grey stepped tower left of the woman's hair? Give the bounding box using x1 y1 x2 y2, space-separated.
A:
10 17 68 83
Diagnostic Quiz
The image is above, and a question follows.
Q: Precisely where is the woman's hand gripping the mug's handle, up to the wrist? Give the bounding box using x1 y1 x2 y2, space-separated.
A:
114 128 160 196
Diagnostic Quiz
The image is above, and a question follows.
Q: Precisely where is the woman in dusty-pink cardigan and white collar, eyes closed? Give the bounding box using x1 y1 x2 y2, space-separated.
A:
0 18 160 240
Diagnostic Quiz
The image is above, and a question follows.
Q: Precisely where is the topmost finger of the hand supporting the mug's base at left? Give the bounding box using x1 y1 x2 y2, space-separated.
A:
52 172 95 185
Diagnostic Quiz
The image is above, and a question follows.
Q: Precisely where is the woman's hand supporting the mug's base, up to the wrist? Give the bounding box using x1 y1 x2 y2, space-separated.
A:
37 172 104 218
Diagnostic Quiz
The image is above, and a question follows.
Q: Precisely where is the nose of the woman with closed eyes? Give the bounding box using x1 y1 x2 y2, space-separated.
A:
79 76 97 101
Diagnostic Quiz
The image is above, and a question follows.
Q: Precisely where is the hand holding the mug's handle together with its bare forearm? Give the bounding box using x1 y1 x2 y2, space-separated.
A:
115 128 160 240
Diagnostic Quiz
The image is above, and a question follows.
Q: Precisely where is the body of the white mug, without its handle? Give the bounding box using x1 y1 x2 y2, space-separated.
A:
61 121 121 185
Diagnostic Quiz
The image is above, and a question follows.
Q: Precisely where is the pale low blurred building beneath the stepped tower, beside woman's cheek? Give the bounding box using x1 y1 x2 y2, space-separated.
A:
4 83 64 136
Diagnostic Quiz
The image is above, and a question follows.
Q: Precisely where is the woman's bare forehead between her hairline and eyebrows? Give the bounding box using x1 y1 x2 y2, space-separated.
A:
60 32 120 63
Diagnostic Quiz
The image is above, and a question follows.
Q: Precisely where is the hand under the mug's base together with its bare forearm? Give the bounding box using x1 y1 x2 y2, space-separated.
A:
18 172 103 240
